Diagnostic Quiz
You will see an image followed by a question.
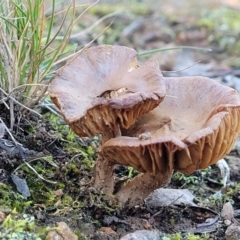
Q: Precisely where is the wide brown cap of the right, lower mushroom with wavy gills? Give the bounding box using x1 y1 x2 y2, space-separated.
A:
100 77 240 174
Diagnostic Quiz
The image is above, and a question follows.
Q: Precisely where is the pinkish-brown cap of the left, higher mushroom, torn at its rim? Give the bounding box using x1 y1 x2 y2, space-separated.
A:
49 45 166 139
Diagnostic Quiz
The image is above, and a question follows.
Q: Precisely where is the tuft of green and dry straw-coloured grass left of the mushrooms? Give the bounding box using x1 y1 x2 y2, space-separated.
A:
0 0 98 129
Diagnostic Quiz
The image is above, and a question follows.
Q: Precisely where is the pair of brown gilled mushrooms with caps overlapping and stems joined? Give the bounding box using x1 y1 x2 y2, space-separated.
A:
49 45 240 206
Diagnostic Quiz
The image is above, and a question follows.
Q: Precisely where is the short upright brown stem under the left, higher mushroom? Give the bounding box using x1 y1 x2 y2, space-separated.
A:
93 156 116 194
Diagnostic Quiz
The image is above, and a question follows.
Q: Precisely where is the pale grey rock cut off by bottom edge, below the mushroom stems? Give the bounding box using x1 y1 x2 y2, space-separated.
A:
120 230 162 240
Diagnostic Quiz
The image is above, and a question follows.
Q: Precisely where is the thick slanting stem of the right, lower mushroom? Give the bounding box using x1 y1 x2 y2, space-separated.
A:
115 171 172 207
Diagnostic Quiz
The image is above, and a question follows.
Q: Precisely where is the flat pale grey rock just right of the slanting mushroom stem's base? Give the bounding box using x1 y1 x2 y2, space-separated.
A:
146 188 197 208
